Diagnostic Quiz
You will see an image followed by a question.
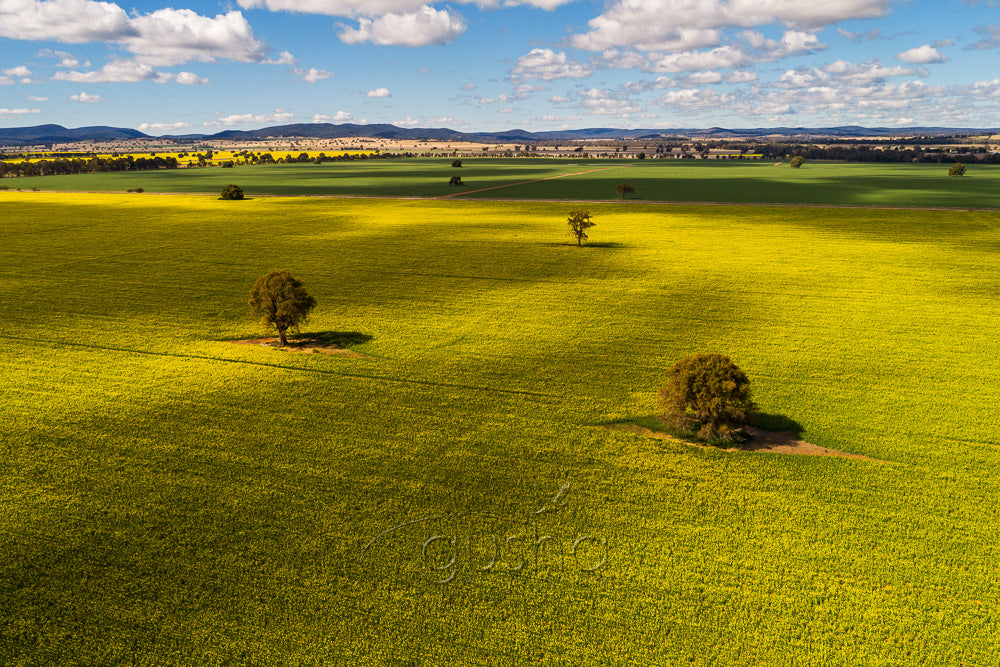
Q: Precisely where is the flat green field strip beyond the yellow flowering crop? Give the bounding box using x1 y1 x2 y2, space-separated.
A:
3 158 1000 208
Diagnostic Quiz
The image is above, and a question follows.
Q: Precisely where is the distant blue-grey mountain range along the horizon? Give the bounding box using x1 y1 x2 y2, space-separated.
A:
0 123 998 146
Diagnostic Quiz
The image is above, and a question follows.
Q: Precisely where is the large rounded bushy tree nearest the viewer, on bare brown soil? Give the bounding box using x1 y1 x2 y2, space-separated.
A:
660 354 756 442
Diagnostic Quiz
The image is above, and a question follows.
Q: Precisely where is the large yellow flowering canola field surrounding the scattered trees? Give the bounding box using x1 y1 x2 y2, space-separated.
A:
0 192 1000 665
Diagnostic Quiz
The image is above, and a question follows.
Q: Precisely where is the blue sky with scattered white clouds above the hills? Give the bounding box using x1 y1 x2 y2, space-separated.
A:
0 0 1000 135
